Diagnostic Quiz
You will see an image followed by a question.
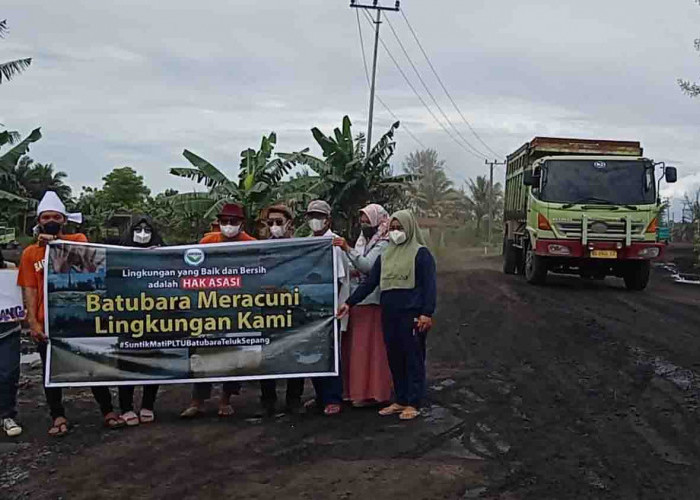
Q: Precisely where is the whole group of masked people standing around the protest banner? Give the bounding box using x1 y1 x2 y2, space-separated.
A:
0 191 436 437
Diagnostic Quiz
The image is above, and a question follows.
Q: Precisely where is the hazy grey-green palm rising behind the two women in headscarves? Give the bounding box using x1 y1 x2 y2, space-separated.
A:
403 149 461 217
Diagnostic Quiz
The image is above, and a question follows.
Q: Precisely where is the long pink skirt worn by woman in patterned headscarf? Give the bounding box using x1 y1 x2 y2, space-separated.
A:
342 305 391 402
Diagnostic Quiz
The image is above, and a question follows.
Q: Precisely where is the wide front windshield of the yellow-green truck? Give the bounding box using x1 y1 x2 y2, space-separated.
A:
540 160 656 205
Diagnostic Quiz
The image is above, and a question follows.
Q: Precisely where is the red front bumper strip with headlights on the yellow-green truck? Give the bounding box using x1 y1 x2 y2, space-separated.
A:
535 239 664 261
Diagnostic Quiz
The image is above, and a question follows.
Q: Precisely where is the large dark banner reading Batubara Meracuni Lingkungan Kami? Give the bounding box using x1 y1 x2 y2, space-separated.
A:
45 238 339 387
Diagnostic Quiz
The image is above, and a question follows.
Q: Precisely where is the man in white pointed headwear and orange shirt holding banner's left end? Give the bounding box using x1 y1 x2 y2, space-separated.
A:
17 191 124 437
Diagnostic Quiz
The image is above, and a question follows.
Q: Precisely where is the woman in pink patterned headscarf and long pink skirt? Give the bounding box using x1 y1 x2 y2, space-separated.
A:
333 204 391 406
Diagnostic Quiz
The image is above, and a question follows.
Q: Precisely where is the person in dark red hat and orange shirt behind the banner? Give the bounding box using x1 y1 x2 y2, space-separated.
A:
180 203 255 418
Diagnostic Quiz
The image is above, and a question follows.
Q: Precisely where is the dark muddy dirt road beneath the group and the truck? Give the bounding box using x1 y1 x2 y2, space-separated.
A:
0 248 700 499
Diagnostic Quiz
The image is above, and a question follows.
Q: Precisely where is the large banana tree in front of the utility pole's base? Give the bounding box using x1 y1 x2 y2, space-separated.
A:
280 116 411 235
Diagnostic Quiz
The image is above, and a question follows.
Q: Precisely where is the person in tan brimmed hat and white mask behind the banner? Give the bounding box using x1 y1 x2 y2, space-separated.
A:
254 204 304 417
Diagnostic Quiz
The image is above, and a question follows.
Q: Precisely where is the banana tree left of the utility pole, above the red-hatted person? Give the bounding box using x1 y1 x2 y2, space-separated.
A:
170 132 308 232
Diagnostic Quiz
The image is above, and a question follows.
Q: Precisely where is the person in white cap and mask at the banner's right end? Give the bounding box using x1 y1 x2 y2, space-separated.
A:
306 200 350 416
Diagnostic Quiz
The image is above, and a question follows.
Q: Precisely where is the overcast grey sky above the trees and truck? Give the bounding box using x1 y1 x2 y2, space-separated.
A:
0 0 700 215
